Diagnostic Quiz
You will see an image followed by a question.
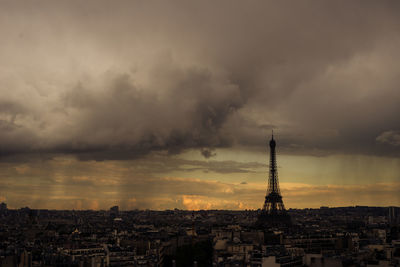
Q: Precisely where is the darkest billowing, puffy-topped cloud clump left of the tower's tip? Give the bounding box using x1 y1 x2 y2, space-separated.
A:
56 59 243 159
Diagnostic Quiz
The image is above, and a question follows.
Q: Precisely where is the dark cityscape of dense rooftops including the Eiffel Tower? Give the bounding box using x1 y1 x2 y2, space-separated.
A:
0 137 400 267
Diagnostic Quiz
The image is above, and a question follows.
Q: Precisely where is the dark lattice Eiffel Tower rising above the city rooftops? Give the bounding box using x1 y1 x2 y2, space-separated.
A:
256 132 291 228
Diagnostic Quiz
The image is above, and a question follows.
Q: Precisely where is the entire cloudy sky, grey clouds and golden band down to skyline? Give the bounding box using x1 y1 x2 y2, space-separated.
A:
0 0 400 209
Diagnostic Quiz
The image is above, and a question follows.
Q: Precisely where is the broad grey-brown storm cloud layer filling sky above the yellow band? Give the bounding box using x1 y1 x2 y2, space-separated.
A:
0 1 400 160
